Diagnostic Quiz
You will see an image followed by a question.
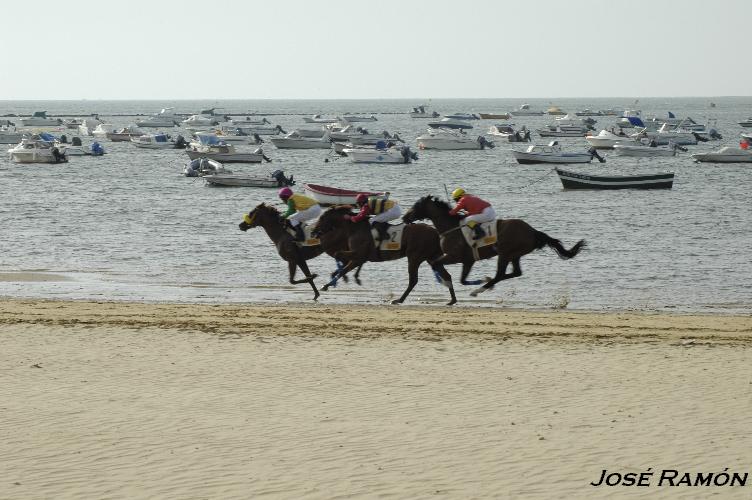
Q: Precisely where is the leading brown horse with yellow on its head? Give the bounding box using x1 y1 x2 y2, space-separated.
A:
238 203 360 300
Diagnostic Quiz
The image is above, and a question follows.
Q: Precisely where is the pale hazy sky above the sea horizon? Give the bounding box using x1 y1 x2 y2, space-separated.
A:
0 0 752 99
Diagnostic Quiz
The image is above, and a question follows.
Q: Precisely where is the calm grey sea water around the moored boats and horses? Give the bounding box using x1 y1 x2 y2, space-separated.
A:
0 98 752 312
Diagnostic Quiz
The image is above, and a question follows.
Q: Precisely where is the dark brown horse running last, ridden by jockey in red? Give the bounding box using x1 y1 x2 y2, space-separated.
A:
402 196 585 297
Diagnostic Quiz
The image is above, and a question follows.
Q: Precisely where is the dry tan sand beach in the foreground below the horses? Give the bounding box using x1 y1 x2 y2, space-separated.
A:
0 300 752 499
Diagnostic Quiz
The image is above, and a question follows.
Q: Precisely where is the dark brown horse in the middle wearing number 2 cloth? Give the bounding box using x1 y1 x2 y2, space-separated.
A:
314 205 457 305
